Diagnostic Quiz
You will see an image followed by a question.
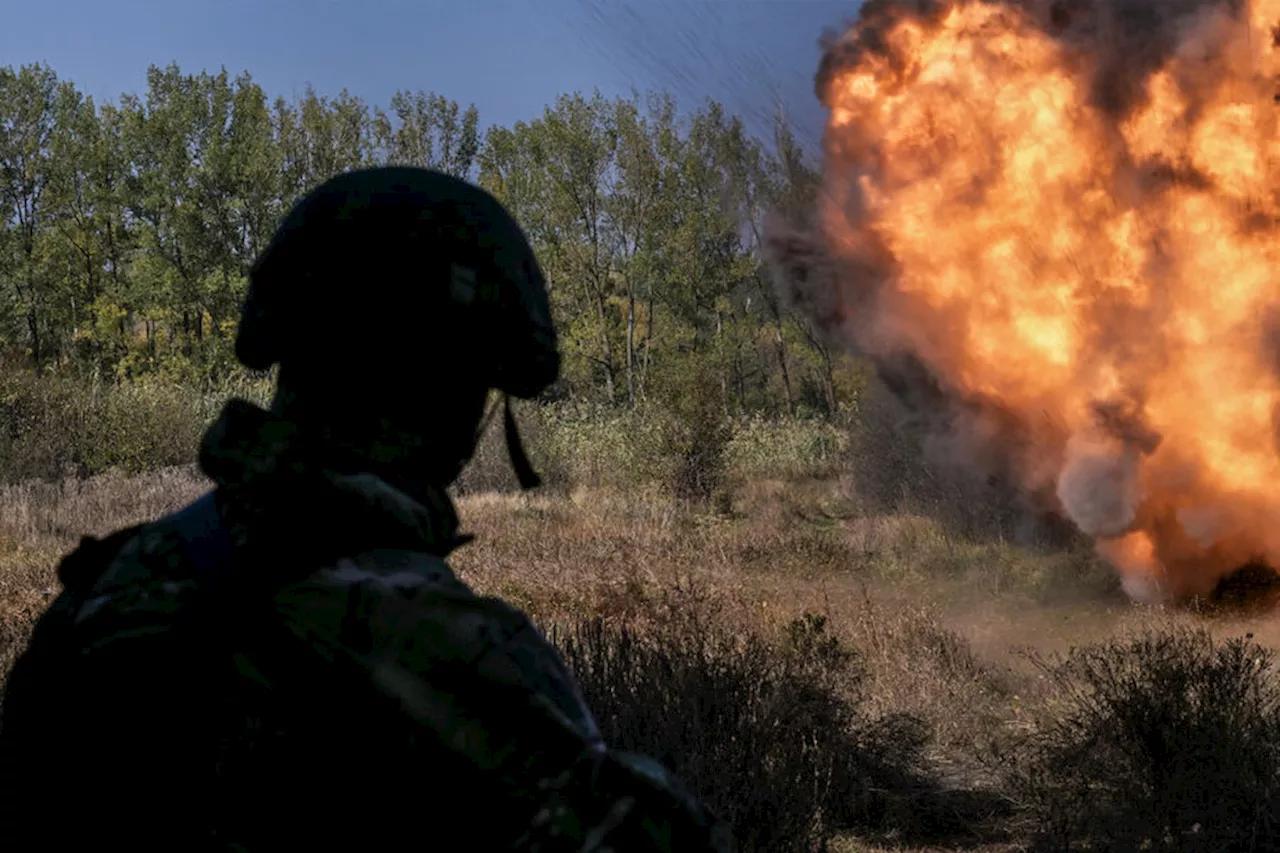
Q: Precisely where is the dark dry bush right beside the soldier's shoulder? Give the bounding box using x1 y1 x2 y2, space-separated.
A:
552 606 927 852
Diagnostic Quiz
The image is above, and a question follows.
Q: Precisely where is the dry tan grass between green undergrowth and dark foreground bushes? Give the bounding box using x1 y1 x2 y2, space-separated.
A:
0 467 1280 852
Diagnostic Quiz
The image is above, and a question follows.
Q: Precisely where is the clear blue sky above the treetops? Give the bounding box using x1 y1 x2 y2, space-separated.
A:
0 0 858 148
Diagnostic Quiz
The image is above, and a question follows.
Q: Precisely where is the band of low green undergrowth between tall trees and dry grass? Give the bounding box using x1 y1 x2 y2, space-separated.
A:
0 370 849 491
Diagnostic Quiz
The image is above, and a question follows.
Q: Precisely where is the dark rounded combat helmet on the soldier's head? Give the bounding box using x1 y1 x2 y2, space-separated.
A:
236 167 559 398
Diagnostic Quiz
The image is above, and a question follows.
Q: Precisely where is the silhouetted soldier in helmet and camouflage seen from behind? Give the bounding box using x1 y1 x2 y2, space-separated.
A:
0 168 728 850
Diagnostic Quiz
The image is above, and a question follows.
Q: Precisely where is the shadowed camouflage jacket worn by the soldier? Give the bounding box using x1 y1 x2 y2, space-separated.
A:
0 401 727 850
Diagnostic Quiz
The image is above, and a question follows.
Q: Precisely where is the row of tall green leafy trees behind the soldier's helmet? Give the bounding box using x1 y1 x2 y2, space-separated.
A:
0 65 847 414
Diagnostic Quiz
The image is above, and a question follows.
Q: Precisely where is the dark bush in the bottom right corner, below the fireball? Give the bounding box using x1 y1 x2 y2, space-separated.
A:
1010 631 1280 852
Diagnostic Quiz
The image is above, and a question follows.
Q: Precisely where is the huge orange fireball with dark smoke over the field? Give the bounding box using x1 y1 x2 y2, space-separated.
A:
773 0 1280 598
